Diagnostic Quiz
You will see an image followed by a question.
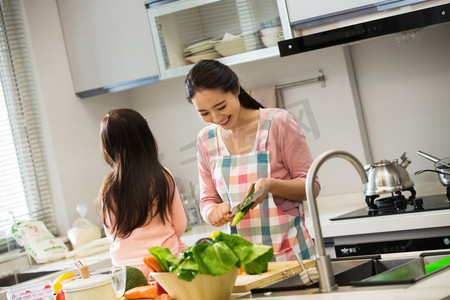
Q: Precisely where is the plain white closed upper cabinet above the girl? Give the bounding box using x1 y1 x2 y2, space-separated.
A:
57 0 159 98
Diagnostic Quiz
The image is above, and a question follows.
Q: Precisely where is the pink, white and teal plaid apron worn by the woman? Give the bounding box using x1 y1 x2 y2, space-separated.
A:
209 109 314 261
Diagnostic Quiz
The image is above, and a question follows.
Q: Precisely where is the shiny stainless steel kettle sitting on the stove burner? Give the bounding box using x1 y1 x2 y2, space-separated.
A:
364 152 414 196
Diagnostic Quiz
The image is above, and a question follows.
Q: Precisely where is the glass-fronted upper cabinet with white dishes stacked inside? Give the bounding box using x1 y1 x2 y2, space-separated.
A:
147 0 292 79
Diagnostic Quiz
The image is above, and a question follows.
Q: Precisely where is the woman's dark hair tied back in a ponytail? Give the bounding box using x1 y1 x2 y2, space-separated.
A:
184 60 264 109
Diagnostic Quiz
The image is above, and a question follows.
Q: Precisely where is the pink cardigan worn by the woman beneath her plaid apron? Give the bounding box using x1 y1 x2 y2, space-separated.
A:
197 109 320 220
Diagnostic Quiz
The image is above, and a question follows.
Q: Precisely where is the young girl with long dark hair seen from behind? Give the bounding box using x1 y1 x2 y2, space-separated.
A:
97 109 186 276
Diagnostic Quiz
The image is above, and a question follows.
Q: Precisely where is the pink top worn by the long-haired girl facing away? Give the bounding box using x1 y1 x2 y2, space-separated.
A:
104 177 187 266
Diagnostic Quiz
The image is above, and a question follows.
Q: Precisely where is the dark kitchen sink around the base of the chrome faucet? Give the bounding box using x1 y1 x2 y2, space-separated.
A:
252 254 450 296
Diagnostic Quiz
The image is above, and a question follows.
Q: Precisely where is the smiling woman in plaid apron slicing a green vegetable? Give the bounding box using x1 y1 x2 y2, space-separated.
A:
185 60 320 261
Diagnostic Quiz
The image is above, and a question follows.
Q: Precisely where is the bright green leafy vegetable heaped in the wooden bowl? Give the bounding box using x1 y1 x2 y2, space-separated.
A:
149 232 273 281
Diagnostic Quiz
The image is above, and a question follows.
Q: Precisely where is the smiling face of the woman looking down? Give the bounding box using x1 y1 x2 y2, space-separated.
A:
192 88 241 130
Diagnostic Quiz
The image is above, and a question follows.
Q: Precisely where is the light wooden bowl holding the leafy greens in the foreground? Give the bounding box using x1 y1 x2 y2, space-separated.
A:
150 267 239 300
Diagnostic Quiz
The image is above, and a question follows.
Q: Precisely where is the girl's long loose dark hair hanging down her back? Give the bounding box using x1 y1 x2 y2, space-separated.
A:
97 108 175 238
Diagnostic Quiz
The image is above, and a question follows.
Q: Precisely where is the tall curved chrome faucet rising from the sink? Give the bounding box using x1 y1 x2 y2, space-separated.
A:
305 150 367 293
